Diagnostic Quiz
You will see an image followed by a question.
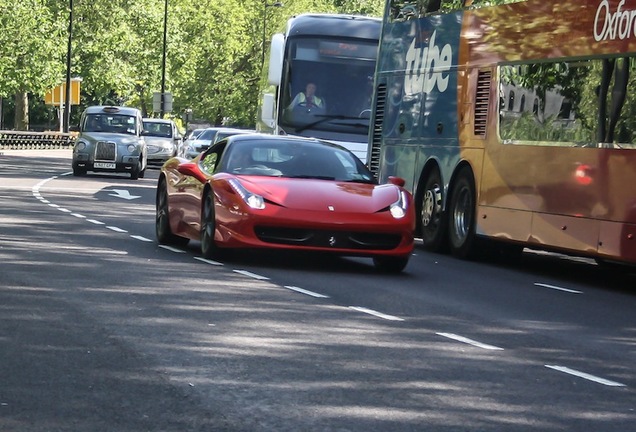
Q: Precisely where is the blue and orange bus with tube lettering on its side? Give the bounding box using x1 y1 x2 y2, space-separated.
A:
368 0 636 264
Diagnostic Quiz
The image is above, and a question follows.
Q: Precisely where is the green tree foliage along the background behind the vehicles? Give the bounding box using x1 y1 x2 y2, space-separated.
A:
0 0 384 127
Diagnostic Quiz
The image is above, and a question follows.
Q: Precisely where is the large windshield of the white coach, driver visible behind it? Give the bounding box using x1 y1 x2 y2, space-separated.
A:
280 37 377 135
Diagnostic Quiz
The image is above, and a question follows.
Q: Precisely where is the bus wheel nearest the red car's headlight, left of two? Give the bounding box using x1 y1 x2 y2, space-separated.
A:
420 169 446 252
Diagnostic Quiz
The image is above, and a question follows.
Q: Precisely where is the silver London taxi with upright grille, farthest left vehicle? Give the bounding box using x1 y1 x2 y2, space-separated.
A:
73 106 148 180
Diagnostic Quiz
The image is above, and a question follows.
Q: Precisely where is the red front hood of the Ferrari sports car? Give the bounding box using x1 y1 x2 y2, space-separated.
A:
237 176 400 213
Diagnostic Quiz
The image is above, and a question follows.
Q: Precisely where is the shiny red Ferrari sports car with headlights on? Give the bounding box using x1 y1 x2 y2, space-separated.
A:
156 134 415 272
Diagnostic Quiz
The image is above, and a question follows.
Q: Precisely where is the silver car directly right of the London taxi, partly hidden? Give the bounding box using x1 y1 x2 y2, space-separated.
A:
143 118 183 165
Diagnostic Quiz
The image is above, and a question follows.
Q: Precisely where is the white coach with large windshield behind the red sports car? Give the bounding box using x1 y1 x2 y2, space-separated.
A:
257 14 382 161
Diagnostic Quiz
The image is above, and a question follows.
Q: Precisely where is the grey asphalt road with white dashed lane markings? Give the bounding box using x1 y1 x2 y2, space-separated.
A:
0 150 636 432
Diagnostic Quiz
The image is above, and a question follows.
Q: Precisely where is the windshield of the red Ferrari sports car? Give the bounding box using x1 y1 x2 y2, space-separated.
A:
222 139 375 183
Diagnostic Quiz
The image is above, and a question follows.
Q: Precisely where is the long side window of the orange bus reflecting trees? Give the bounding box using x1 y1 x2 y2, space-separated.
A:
499 58 636 148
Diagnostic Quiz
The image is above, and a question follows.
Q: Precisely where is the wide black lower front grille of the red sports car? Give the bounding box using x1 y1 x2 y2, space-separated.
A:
255 226 401 250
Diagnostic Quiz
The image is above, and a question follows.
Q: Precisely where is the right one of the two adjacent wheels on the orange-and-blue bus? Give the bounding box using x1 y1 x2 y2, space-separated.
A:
448 167 475 258
